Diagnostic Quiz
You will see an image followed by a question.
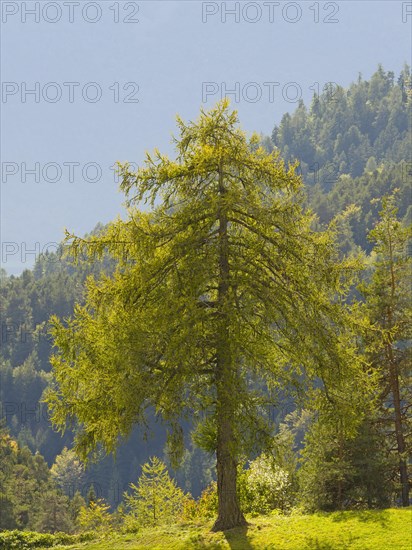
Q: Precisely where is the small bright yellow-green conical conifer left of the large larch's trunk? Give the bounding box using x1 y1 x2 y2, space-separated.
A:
124 457 186 527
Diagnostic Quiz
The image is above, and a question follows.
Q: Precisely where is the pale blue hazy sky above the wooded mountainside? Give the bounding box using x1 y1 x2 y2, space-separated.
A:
1 0 412 273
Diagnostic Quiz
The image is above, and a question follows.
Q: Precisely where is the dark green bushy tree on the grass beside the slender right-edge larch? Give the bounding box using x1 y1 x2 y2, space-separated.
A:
298 408 392 512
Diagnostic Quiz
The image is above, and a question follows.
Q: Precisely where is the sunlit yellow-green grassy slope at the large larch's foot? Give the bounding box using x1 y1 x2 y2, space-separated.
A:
50 508 412 550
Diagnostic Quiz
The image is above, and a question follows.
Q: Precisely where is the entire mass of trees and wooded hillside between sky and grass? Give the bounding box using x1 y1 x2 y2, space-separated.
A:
0 66 412 548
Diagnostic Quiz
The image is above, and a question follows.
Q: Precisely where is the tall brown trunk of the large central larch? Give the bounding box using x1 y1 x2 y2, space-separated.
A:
212 162 247 531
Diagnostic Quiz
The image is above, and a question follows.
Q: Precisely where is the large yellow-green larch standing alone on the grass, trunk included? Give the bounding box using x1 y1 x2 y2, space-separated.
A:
46 100 362 530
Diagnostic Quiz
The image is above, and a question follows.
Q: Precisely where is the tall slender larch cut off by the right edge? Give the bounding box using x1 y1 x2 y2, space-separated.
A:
360 195 412 506
